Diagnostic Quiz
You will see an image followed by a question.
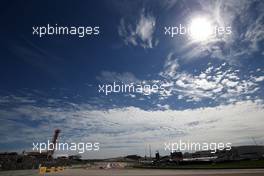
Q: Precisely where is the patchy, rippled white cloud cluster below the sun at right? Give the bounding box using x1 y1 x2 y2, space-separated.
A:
160 59 264 102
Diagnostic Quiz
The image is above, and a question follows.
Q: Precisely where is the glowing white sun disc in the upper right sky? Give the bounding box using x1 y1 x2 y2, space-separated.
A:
189 17 213 41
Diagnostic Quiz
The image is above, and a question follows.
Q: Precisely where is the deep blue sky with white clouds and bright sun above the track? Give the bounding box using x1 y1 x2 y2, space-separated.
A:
0 0 264 158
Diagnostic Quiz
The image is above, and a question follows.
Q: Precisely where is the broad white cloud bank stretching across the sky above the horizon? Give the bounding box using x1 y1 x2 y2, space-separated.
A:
0 100 264 158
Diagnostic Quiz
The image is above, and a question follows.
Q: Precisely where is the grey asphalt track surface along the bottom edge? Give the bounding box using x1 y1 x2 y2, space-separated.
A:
0 169 264 176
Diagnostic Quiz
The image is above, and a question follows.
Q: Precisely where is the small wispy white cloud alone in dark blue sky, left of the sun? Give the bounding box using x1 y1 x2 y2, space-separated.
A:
118 10 158 48
